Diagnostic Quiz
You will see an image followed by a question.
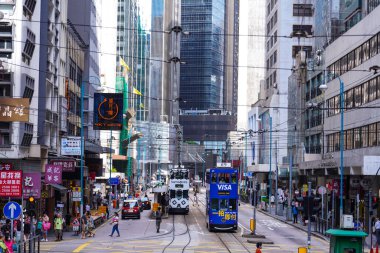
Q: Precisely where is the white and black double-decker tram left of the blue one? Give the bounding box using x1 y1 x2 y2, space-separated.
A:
169 168 190 214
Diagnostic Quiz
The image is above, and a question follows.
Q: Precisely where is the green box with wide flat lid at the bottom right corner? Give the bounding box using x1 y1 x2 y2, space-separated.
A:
326 229 367 253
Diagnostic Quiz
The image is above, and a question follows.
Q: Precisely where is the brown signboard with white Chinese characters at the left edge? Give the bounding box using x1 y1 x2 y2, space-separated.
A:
0 98 29 122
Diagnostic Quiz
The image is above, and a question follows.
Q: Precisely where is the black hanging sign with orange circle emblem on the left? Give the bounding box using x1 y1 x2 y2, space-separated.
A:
94 93 123 130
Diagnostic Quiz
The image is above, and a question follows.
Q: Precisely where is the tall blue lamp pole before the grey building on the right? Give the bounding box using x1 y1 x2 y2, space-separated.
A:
338 76 344 217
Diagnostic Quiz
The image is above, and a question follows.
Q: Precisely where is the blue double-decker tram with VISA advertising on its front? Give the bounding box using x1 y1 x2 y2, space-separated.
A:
206 168 239 231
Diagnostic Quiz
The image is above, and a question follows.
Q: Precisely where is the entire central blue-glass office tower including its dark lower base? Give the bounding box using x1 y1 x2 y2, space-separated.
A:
180 0 239 143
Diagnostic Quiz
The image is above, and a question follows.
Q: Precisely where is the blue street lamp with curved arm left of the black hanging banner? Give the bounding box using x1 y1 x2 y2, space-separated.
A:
80 76 104 217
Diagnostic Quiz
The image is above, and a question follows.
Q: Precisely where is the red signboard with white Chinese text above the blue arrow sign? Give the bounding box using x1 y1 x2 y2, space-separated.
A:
0 170 22 197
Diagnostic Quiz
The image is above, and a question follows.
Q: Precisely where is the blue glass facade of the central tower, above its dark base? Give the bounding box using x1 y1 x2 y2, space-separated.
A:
180 0 225 110
